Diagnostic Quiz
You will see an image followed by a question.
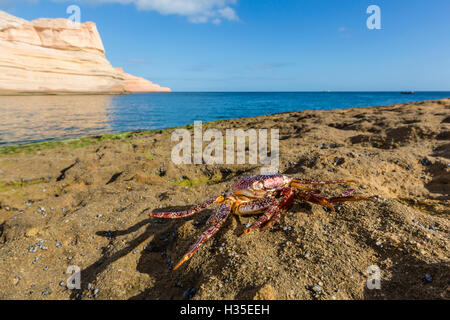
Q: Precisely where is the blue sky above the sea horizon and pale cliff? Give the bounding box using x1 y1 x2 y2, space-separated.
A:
0 0 450 91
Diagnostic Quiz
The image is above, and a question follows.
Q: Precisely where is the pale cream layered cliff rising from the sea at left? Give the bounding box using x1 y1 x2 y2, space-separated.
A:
0 11 170 94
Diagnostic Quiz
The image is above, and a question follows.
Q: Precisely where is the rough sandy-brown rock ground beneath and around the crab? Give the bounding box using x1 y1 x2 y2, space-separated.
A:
0 99 450 299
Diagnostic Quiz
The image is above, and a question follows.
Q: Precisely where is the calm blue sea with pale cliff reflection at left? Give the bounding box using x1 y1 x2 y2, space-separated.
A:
0 92 450 145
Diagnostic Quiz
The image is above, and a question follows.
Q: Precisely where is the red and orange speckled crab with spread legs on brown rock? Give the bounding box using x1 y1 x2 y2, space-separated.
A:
150 174 373 270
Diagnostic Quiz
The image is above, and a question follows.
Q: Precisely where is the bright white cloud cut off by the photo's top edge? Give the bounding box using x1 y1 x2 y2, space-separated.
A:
63 0 239 24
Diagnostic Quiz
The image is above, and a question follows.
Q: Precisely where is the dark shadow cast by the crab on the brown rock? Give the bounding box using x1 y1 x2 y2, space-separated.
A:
70 206 211 299
